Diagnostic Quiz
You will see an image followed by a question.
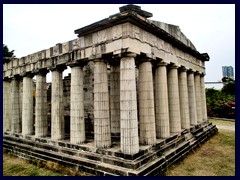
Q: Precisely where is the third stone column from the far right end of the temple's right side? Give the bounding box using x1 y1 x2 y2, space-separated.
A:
187 70 197 126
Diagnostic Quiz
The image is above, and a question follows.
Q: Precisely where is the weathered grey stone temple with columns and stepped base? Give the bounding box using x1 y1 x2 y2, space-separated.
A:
3 5 217 176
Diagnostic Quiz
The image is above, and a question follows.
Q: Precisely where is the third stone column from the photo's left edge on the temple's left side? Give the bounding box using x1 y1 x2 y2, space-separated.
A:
22 74 34 135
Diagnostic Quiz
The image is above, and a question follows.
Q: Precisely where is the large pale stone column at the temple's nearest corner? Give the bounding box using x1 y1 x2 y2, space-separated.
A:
120 54 139 154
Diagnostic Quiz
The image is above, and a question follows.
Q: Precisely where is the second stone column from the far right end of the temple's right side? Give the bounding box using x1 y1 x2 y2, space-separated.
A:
194 72 203 123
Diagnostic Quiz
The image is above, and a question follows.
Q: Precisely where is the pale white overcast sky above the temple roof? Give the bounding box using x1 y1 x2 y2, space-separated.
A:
3 4 235 89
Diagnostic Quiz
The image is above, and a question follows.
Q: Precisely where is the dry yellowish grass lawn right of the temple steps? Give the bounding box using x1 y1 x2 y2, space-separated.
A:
166 120 235 176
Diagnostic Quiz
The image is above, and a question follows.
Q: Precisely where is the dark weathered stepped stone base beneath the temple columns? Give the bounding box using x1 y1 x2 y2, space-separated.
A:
3 124 217 176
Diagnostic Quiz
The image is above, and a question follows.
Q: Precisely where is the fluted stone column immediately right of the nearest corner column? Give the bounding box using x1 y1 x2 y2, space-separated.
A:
138 59 156 145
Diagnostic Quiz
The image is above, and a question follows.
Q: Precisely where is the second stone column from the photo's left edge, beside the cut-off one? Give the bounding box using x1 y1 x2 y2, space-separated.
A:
10 77 22 133
